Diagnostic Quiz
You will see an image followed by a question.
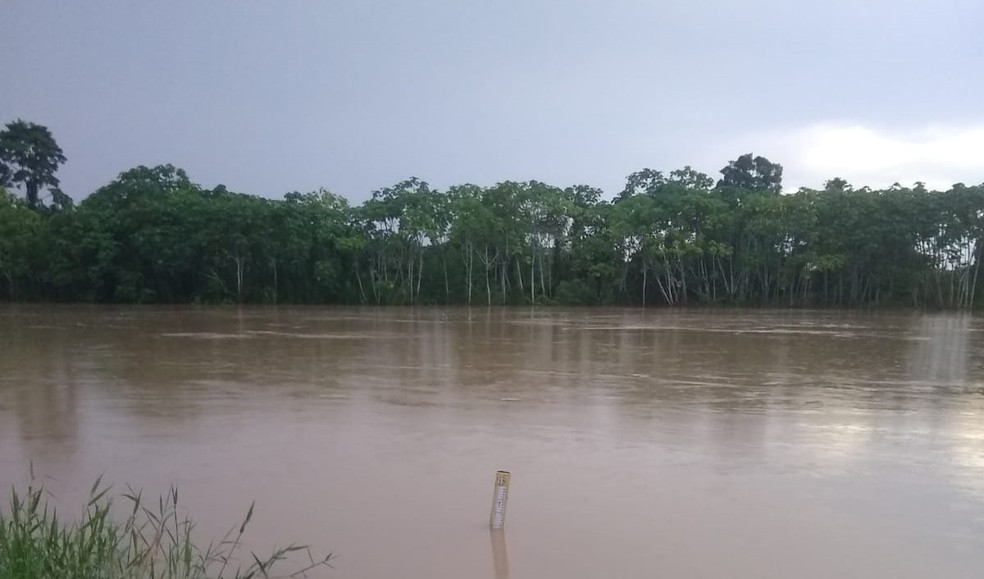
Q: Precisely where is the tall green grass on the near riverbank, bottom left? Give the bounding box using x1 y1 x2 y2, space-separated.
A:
0 480 331 579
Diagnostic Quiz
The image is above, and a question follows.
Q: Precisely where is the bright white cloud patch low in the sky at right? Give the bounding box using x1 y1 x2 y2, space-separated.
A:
741 123 984 189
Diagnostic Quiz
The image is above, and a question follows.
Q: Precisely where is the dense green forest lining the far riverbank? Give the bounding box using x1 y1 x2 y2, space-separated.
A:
0 121 984 309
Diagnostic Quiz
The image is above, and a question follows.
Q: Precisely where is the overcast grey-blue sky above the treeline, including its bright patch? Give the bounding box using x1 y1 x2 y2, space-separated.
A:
0 0 984 201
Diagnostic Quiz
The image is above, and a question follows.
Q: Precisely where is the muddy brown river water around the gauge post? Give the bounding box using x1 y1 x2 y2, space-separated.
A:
0 306 984 579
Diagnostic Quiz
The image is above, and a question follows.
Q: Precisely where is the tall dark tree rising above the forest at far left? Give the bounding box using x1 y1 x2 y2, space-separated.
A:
0 120 71 209
